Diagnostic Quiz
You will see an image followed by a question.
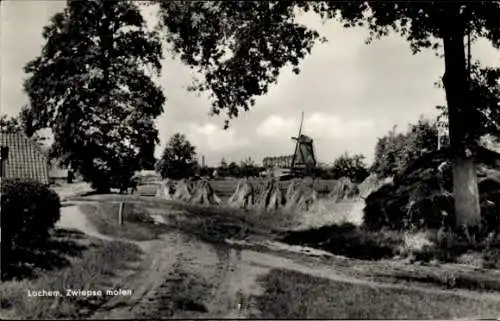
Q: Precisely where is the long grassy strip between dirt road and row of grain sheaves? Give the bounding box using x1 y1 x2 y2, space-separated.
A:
77 195 295 243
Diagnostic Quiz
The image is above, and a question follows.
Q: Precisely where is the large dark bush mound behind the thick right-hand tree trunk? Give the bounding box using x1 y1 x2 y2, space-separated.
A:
364 149 500 232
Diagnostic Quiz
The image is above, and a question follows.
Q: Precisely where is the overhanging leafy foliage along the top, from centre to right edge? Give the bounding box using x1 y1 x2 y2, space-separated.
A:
160 1 500 130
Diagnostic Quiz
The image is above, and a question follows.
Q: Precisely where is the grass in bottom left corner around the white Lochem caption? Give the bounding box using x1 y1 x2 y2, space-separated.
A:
0 241 142 320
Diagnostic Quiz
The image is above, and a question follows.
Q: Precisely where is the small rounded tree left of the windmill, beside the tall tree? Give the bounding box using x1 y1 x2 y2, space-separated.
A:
156 133 198 179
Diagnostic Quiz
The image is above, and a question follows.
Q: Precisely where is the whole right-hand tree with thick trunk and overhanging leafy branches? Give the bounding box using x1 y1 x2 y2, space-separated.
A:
160 1 500 227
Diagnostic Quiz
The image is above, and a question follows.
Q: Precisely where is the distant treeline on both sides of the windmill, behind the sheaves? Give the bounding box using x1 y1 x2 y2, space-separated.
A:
151 116 439 182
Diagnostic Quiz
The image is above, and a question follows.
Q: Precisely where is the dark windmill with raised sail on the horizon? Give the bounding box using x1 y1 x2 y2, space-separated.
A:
291 112 316 174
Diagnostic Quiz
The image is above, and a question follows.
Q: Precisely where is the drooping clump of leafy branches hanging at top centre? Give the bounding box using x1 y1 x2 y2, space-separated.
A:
160 1 319 128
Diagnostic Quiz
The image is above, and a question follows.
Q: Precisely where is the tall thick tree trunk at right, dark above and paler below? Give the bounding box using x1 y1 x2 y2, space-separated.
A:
443 6 481 228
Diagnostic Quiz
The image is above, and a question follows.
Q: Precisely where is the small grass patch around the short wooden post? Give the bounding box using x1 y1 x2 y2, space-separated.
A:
80 201 165 241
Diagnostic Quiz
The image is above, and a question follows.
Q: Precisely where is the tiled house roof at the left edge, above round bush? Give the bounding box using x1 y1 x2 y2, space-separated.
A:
0 133 49 184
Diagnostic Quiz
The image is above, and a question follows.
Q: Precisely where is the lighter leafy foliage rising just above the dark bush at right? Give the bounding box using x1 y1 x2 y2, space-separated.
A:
371 117 438 177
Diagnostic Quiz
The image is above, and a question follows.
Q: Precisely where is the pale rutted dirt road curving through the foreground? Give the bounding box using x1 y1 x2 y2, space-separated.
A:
53 192 500 319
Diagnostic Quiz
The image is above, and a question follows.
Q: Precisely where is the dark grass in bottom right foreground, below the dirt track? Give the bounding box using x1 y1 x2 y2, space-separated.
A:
256 270 500 319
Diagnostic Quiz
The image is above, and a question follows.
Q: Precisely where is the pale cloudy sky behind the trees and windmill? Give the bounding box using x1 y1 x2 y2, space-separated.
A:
0 0 500 165
